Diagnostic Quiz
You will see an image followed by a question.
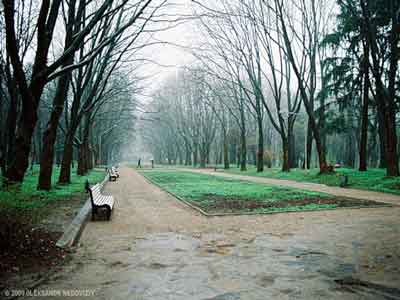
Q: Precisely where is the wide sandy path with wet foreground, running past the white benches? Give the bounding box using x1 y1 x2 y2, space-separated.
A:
29 168 400 300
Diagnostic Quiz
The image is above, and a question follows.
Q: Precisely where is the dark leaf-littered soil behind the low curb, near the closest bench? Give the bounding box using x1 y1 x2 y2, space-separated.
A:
0 195 84 291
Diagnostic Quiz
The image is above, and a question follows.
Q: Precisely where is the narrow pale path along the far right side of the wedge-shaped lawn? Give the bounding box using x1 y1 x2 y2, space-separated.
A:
178 168 400 205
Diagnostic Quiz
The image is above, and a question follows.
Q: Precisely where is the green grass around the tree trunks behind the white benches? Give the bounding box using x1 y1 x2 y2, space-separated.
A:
0 166 104 213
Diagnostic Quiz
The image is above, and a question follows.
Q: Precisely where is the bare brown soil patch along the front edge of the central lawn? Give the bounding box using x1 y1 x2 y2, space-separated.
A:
189 194 387 213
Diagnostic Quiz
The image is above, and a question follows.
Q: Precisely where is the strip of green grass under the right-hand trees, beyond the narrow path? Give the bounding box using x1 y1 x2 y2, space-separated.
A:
224 166 400 195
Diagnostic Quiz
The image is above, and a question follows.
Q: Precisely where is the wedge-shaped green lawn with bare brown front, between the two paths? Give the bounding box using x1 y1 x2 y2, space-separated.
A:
141 169 386 214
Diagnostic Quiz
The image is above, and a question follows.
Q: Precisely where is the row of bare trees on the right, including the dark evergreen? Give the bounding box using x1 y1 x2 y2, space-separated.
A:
147 0 400 176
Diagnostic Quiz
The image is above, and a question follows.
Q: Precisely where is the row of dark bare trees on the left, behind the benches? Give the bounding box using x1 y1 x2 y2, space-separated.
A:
0 0 165 190
